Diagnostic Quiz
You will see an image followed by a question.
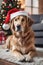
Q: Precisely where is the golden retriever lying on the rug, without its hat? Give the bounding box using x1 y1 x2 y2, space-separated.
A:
6 15 36 61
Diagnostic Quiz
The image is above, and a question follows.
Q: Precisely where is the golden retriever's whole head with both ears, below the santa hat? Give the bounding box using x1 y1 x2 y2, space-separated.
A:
11 16 33 33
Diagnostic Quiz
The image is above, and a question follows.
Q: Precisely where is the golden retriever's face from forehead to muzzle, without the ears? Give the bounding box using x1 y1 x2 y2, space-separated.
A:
13 16 26 32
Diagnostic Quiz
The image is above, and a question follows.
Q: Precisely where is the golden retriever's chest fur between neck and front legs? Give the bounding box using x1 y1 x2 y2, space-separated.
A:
10 29 33 54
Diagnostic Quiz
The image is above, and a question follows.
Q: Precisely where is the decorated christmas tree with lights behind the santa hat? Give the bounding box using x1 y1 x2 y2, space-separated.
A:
0 0 21 25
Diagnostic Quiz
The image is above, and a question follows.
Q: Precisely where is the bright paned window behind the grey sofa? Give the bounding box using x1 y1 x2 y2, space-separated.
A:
25 0 39 14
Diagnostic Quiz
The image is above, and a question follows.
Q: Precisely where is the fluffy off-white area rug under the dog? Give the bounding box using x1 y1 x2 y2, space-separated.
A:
0 48 43 65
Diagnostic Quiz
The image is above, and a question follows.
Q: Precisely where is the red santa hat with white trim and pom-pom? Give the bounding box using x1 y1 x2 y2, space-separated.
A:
2 8 30 30
